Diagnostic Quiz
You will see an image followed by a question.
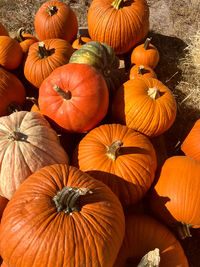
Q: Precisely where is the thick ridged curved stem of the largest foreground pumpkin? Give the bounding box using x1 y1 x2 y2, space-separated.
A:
53 186 92 214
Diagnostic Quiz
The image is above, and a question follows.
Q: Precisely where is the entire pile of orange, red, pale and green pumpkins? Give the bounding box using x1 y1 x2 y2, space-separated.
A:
0 0 200 267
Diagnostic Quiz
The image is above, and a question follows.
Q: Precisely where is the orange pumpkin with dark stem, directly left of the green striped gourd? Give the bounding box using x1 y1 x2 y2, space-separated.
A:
24 39 74 88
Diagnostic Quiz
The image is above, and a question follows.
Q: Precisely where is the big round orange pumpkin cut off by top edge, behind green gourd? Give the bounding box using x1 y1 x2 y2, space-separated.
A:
87 0 149 55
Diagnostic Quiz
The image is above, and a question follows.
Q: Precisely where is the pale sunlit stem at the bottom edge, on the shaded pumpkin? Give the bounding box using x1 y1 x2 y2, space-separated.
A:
137 248 160 267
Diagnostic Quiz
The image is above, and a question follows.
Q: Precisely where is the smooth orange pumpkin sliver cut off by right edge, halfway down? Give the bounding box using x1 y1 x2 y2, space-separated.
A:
181 119 200 162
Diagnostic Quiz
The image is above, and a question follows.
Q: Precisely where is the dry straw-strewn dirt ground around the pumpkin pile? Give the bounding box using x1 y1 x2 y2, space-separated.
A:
0 0 200 267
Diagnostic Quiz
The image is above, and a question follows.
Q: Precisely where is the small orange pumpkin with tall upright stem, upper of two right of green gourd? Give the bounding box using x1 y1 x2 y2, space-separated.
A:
131 38 160 69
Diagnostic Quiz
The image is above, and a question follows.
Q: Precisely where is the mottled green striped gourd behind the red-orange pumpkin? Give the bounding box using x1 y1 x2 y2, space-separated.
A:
69 41 125 96
